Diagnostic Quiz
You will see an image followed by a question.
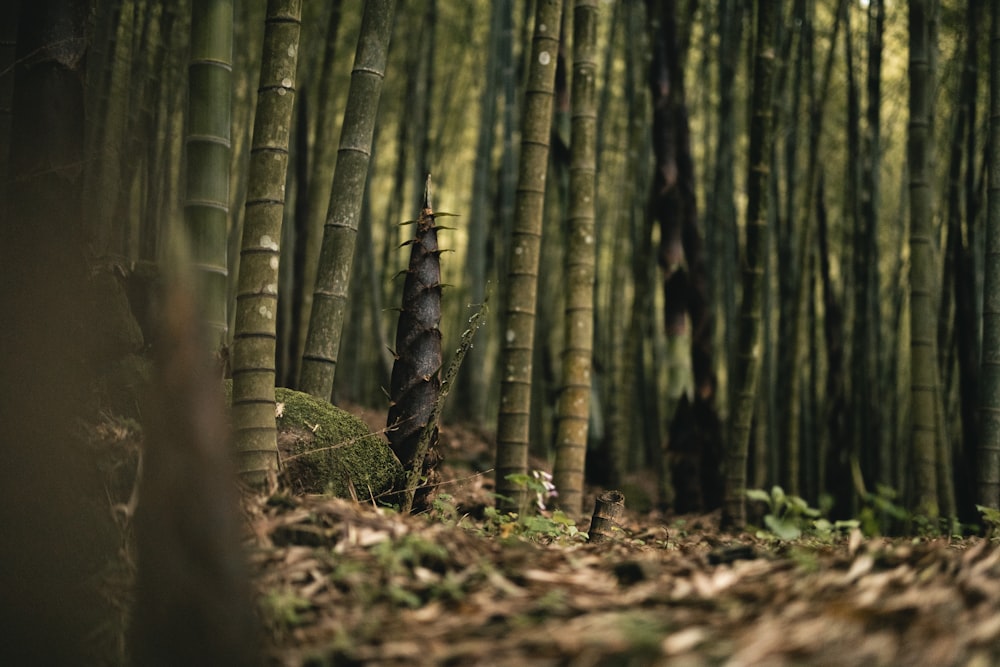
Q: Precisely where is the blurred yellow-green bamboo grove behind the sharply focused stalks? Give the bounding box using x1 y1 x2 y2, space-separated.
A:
0 0 996 521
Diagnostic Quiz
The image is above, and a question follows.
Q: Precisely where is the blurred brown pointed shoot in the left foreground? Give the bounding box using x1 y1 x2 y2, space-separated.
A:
131 280 261 665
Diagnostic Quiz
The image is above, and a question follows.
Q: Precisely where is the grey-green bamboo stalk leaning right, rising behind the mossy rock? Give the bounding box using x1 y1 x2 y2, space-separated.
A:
299 0 396 400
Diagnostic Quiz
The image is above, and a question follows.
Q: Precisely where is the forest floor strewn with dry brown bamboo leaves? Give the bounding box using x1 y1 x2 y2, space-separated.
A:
249 414 1000 667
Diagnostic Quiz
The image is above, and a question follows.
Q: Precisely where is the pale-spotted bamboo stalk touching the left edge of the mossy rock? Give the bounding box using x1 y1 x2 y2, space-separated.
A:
231 0 302 485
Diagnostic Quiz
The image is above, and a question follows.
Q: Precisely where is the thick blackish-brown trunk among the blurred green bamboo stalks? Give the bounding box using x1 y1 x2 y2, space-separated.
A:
647 0 721 512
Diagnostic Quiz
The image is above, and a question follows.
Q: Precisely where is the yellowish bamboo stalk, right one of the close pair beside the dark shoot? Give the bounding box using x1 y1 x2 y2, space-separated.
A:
553 0 600 516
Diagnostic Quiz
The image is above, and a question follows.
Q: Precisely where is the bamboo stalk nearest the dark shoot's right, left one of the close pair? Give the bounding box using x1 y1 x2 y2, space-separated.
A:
496 0 562 511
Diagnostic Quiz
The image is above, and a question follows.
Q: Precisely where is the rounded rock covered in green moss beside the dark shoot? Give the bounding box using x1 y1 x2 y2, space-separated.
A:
226 380 403 499
